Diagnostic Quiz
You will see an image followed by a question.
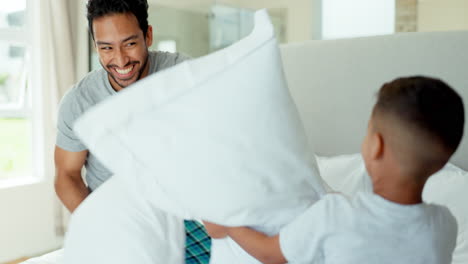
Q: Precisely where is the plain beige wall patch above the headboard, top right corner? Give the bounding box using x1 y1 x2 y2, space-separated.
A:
418 0 468 31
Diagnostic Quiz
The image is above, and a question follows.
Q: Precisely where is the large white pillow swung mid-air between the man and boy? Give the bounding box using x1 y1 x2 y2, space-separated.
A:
76 11 324 227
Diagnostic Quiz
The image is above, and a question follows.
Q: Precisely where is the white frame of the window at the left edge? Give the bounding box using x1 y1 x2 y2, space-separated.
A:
0 0 46 186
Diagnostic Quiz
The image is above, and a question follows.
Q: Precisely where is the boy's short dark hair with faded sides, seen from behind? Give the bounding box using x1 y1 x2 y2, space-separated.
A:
375 76 465 153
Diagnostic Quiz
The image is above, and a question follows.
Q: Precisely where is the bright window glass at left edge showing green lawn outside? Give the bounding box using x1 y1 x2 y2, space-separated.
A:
0 0 32 181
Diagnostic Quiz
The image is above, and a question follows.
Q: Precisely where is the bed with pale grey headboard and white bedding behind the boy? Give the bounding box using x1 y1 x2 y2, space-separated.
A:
25 28 468 264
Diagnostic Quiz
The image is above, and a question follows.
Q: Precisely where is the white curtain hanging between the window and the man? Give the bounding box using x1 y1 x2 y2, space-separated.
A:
33 0 77 236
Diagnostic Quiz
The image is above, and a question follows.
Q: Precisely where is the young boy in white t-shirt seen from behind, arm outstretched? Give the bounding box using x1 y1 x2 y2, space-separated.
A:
206 77 464 264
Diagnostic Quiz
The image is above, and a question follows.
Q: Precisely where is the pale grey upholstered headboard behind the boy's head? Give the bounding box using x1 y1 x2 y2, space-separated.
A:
281 31 468 170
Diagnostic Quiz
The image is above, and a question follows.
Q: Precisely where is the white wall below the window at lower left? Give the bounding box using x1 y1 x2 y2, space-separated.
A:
0 181 62 263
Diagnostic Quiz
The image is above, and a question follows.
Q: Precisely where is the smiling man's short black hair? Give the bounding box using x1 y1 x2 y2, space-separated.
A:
87 0 148 39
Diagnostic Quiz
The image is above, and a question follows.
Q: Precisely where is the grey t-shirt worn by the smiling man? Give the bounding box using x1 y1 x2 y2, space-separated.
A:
56 51 188 190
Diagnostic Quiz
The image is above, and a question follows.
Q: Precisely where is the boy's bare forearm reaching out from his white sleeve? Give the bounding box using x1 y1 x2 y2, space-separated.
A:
227 227 287 264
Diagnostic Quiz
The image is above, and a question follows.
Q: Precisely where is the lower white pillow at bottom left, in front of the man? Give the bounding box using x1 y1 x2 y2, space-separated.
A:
64 175 185 264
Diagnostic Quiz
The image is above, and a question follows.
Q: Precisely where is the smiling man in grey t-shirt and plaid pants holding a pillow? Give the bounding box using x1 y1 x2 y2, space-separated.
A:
55 0 209 263
